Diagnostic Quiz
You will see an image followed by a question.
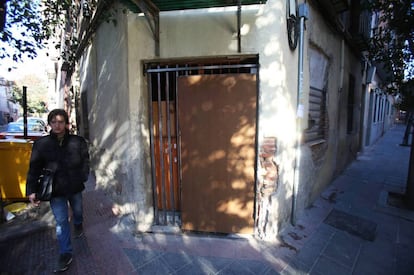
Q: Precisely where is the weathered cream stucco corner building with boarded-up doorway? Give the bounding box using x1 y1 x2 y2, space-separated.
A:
53 0 393 240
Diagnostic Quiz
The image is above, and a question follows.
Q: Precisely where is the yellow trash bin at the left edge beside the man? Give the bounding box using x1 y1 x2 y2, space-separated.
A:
0 140 32 199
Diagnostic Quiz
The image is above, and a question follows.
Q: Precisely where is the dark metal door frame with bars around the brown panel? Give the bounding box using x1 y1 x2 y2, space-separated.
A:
144 55 259 226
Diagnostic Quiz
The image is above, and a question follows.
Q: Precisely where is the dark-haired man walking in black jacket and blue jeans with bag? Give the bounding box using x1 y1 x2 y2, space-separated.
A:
26 109 89 272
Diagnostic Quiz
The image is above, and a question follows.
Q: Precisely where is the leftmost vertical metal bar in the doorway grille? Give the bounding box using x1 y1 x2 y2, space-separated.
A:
147 73 160 224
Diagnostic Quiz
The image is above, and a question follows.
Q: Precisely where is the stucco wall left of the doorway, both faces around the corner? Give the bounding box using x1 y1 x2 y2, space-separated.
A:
80 4 154 233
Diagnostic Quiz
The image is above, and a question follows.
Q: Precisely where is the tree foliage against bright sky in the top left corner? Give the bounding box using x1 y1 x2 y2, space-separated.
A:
0 0 116 73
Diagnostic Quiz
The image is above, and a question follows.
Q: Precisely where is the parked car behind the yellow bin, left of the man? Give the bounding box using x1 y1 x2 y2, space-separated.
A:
0 122 48 140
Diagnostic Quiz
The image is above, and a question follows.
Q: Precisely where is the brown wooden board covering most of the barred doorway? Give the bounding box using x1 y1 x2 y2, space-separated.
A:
177 74 257 234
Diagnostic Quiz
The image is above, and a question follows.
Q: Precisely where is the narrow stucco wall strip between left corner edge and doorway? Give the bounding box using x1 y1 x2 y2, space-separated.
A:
124 13 155 231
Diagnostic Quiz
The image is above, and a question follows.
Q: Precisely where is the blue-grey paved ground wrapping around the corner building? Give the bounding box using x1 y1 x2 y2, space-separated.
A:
0 125 414 275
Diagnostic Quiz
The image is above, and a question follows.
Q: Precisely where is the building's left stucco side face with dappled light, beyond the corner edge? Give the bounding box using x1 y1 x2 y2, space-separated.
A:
81 11 129 191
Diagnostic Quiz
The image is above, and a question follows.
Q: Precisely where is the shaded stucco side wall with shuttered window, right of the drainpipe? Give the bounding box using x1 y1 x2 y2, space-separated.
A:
297 2 361 218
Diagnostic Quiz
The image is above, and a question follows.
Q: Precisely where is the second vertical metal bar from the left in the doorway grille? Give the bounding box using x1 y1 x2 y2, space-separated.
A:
157 66 167 224
